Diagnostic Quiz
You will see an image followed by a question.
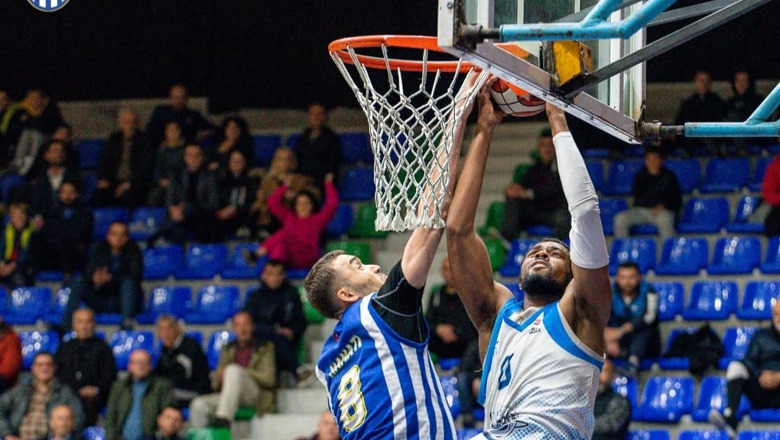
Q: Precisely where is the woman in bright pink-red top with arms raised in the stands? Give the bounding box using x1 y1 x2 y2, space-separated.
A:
248 174 339 268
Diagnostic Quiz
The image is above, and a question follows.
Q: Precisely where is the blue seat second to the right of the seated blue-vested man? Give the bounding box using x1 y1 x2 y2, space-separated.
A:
682 281 738 321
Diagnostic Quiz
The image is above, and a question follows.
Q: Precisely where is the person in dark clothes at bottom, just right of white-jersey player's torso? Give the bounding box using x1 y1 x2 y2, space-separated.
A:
593 359 631 440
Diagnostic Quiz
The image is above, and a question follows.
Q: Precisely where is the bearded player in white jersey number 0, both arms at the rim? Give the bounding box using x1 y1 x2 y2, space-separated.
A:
447 94 611 440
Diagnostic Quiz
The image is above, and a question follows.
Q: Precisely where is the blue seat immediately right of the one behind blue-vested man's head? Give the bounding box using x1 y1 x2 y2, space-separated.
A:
655 237 709 275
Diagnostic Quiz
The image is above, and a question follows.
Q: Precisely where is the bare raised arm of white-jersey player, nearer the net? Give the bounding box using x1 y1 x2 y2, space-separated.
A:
447 80 512 359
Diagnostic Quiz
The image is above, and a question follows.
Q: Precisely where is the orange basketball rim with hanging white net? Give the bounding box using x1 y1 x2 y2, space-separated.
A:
328 35 487 231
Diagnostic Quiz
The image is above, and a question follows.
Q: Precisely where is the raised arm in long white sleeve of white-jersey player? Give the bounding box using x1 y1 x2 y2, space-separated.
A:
547 103 612 353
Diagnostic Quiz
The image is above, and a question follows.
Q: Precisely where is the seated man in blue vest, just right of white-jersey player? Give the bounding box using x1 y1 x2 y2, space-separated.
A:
604 261 661 377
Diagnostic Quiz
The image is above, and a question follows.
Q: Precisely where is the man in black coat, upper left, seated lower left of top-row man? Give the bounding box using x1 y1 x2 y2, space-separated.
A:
92 110 153 209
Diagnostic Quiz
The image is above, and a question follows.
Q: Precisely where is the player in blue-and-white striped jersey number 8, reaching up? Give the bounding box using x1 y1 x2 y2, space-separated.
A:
305 76 489 440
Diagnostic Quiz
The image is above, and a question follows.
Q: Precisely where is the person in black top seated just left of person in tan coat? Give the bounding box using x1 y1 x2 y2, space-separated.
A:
216 150 257 240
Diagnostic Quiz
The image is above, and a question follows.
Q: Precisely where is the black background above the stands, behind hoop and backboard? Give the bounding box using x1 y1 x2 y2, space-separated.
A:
0 0 780 111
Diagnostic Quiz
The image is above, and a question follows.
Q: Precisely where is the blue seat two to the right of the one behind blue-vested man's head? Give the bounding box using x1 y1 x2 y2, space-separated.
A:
707 236 761 275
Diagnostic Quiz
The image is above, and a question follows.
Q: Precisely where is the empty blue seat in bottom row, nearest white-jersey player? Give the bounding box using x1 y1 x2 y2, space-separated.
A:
634 377 693 423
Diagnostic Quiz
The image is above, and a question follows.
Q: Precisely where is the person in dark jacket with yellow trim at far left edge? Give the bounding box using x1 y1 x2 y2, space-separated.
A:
0 203 38 289
